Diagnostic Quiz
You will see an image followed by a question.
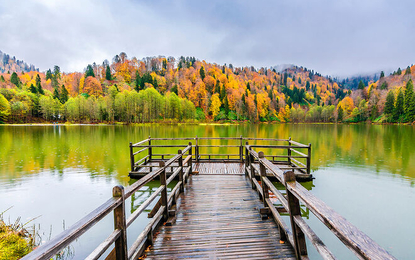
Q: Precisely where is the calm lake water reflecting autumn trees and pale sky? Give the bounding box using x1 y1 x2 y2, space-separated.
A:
0 124 415 259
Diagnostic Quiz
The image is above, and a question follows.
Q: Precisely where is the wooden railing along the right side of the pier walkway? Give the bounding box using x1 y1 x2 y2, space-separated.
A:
245 146 395 259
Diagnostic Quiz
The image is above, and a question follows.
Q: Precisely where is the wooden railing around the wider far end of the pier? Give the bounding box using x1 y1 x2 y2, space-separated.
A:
130 136 311 174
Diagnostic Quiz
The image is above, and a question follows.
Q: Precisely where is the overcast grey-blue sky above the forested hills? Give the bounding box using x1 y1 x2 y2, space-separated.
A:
0 0 415 77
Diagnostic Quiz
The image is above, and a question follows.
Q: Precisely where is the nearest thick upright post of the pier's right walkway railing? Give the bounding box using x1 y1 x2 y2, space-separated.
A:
284 171 307 259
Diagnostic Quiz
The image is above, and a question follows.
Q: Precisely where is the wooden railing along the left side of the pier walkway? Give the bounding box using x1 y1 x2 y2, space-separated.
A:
22 143 192 260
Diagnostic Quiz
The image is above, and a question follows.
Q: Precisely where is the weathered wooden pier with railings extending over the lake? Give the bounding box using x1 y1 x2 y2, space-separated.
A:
23 137 395 259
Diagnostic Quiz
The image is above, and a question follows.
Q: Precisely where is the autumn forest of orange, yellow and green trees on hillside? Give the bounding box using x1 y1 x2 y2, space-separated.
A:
0 53 415 123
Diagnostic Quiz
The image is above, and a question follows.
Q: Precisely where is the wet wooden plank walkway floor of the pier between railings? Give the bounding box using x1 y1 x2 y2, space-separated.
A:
146 174 295 259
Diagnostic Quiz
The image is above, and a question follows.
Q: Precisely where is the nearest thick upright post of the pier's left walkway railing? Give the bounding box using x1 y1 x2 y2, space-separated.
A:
112 185 128 260
